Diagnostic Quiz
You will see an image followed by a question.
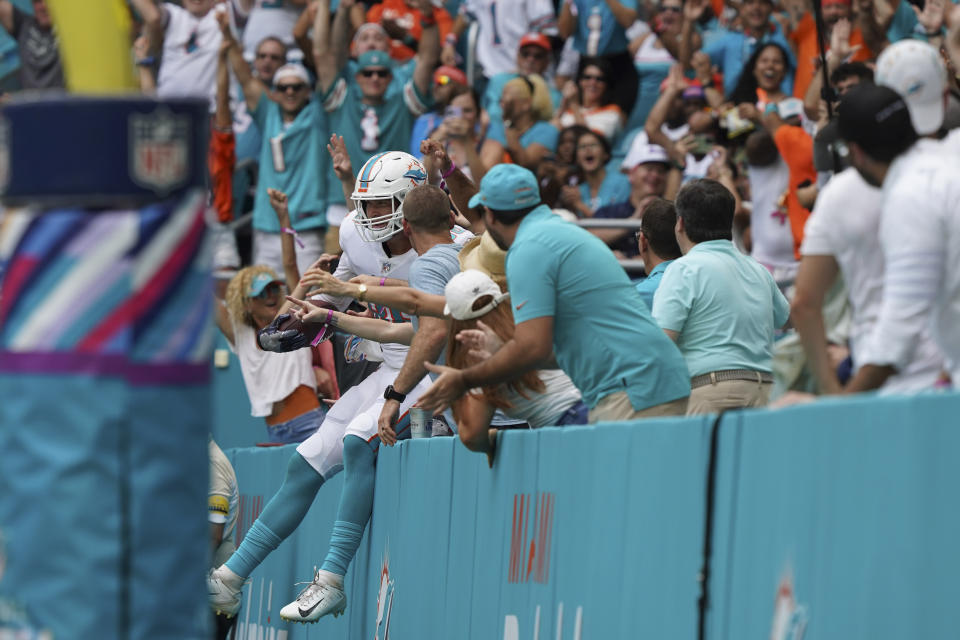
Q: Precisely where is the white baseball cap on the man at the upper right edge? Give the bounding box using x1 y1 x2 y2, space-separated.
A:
874 40 947 135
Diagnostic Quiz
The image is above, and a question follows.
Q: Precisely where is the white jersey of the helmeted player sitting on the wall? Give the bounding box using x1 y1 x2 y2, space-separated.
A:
319 211 473 369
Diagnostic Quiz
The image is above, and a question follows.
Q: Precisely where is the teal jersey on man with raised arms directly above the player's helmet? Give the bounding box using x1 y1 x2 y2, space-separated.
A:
323 71 433 204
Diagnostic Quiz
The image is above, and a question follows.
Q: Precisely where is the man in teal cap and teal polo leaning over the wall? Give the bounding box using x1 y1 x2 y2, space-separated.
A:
420 164 690 422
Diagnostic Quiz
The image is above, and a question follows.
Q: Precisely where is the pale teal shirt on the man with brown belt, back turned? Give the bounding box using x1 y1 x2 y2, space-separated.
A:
653 240 790 377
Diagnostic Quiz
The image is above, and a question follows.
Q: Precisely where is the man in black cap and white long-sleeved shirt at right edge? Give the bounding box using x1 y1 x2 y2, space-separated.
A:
839 85 960 392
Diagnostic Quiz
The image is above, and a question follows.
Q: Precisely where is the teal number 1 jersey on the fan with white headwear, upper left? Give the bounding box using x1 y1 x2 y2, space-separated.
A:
250 93 333 233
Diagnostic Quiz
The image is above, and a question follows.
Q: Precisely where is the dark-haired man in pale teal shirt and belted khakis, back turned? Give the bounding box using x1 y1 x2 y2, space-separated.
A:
653 180 790 413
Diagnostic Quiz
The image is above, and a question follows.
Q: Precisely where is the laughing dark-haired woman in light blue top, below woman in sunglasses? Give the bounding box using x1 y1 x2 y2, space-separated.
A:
560 130 630 218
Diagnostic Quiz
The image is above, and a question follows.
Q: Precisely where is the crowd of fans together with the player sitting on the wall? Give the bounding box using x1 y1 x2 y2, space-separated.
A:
0 0 960 622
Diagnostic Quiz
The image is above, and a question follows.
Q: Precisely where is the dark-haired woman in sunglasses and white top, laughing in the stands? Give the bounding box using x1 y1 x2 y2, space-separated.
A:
554 58 626 140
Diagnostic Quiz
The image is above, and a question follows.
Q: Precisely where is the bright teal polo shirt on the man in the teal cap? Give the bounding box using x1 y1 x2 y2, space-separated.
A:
506 205 690 410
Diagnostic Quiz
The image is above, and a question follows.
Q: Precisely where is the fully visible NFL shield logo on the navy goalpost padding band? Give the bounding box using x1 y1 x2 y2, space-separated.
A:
129 109 190 196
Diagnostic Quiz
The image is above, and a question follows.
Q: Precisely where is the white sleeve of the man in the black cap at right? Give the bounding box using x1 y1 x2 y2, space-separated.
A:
862 170 953 371
